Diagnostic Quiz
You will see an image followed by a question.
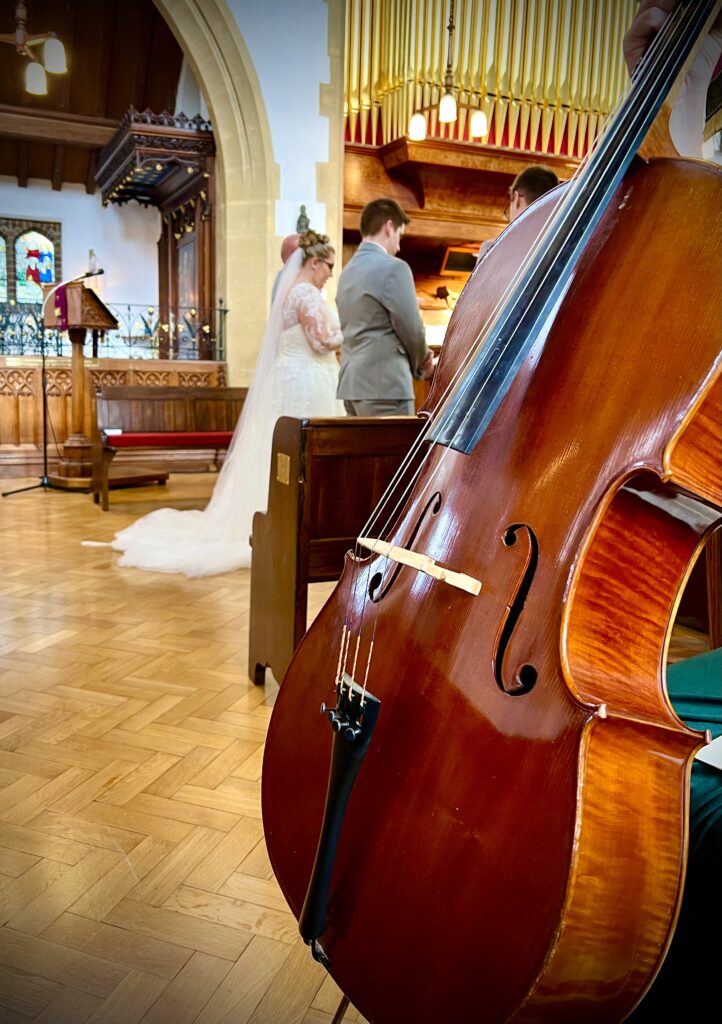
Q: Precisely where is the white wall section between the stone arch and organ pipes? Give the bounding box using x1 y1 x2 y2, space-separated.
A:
228 0 331 237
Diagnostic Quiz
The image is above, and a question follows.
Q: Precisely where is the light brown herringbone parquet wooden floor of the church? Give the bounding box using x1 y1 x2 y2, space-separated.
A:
0 474 704 1024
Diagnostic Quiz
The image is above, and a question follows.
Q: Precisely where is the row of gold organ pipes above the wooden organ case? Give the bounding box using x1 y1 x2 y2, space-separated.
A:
344 0 635 158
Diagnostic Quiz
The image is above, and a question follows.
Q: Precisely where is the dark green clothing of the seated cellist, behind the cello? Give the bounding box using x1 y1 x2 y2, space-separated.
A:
627 648 722 1024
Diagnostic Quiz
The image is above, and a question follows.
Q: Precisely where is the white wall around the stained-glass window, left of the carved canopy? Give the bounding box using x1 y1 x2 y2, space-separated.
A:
0 177 161 306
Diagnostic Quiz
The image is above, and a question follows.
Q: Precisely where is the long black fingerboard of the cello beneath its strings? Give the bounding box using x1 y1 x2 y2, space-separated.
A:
428 0 719 453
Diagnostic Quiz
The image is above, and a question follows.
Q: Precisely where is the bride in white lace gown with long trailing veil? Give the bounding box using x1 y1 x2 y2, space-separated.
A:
107 231 344 577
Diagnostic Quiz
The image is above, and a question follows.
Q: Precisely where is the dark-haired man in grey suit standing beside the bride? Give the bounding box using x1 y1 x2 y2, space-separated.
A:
336 199 433 416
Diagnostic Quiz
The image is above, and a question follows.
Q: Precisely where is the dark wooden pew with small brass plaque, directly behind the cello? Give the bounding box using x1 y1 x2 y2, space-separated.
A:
249 416 423 684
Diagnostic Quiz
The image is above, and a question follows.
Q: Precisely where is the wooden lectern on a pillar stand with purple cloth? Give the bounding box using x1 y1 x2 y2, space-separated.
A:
43 281 118 490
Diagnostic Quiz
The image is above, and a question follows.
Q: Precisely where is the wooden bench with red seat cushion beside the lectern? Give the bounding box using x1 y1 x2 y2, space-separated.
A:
90 386 248 511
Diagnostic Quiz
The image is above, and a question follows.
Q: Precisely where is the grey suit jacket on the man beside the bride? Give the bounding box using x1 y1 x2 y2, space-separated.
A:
336 242 427 401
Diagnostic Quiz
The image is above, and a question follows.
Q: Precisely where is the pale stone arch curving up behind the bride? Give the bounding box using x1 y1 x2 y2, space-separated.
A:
154 0 280 384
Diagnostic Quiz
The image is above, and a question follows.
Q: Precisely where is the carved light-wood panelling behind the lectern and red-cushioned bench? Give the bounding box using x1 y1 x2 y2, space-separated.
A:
0 356 226 476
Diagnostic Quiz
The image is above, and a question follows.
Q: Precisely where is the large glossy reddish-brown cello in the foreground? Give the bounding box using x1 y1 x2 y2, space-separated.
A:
262 0 722 1024
